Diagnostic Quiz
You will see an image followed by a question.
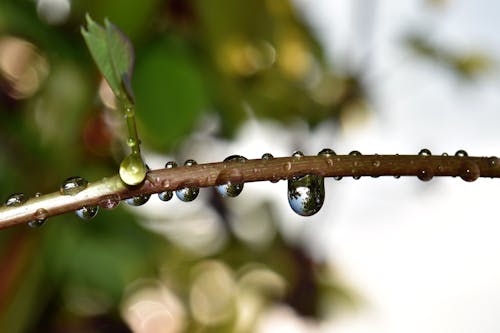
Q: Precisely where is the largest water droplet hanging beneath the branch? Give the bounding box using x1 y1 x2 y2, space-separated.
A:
288 175 325 216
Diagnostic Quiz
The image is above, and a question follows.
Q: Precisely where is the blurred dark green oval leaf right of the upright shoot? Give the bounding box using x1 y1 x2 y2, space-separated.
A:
133 38 207 150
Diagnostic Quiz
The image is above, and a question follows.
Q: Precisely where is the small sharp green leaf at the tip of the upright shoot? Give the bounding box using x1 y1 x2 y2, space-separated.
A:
81 15 134 103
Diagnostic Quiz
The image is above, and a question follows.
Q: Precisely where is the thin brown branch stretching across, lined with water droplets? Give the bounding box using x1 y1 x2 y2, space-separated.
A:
0 155 500 228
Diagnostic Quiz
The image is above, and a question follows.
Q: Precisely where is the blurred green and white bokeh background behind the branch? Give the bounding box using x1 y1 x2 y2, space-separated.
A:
0 0 500 333
